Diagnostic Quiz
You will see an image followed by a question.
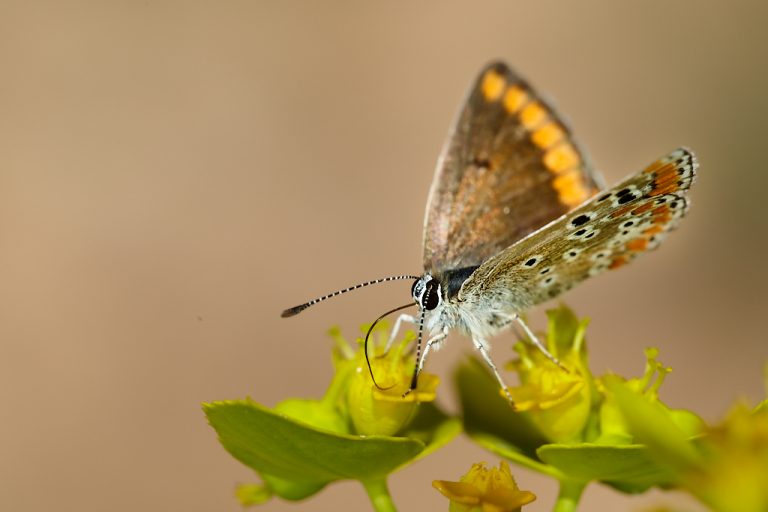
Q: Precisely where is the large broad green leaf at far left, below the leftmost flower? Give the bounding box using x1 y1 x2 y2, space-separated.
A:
203 399 424 485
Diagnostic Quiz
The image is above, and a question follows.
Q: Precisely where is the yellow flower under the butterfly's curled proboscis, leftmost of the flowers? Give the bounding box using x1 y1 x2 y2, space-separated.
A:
347 326 440 436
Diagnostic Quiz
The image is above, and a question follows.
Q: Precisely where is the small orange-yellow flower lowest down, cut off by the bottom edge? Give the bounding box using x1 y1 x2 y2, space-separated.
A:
432 461 536 512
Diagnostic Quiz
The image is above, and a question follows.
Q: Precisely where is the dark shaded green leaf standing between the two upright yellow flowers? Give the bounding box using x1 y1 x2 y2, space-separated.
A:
454 357 548 459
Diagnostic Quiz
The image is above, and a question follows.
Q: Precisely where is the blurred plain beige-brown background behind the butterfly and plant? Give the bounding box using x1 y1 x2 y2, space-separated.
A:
0 1 768 512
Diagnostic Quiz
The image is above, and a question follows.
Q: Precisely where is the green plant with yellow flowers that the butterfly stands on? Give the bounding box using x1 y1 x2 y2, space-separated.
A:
204 306 768 512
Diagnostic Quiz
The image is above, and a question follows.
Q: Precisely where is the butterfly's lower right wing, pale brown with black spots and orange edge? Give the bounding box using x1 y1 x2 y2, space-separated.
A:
459 149 697 311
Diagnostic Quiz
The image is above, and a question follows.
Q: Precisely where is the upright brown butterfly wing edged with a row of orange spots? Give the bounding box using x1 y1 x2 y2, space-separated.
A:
424 63 601 272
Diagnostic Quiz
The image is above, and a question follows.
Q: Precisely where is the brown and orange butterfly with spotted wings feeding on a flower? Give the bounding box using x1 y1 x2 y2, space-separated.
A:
282 62 698 403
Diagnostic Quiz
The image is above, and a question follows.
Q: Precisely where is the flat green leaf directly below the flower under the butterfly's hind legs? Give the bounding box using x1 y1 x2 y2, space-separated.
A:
538 443 674 492
